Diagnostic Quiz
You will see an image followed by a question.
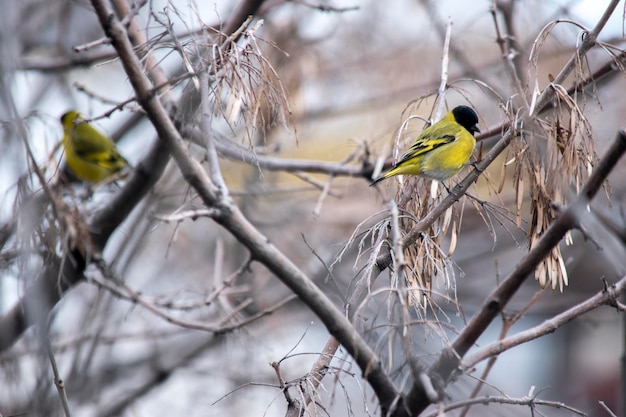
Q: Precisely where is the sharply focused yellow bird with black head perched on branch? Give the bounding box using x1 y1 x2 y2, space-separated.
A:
370 106 480 185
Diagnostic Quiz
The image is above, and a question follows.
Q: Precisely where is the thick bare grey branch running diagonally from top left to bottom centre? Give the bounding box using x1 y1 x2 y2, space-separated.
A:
92 0 397 410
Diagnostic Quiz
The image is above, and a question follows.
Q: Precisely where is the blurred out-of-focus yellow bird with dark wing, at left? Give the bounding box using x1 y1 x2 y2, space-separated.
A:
61 110 128 183
